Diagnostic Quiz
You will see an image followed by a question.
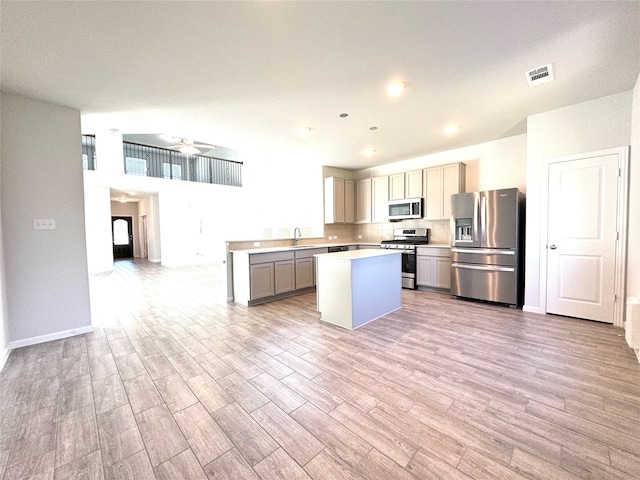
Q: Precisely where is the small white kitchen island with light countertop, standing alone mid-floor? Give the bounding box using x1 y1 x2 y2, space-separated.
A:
315 250 402 330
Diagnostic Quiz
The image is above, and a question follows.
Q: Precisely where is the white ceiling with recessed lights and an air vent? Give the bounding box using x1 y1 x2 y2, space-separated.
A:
0 0 640 169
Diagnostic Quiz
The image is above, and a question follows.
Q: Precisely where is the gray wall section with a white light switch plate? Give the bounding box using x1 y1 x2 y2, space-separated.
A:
1 92 91 347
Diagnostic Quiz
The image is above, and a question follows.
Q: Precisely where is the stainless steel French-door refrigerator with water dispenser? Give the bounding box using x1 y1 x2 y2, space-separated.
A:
450 188 524 308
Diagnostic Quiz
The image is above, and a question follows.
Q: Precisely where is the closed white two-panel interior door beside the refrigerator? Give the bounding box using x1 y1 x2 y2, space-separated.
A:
547 154 618 323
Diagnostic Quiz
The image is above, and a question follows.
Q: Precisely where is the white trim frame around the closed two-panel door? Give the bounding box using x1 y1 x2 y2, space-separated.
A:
538 145 629 327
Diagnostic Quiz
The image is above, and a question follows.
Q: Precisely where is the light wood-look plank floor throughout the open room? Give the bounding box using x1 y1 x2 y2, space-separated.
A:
0 261 640 480
